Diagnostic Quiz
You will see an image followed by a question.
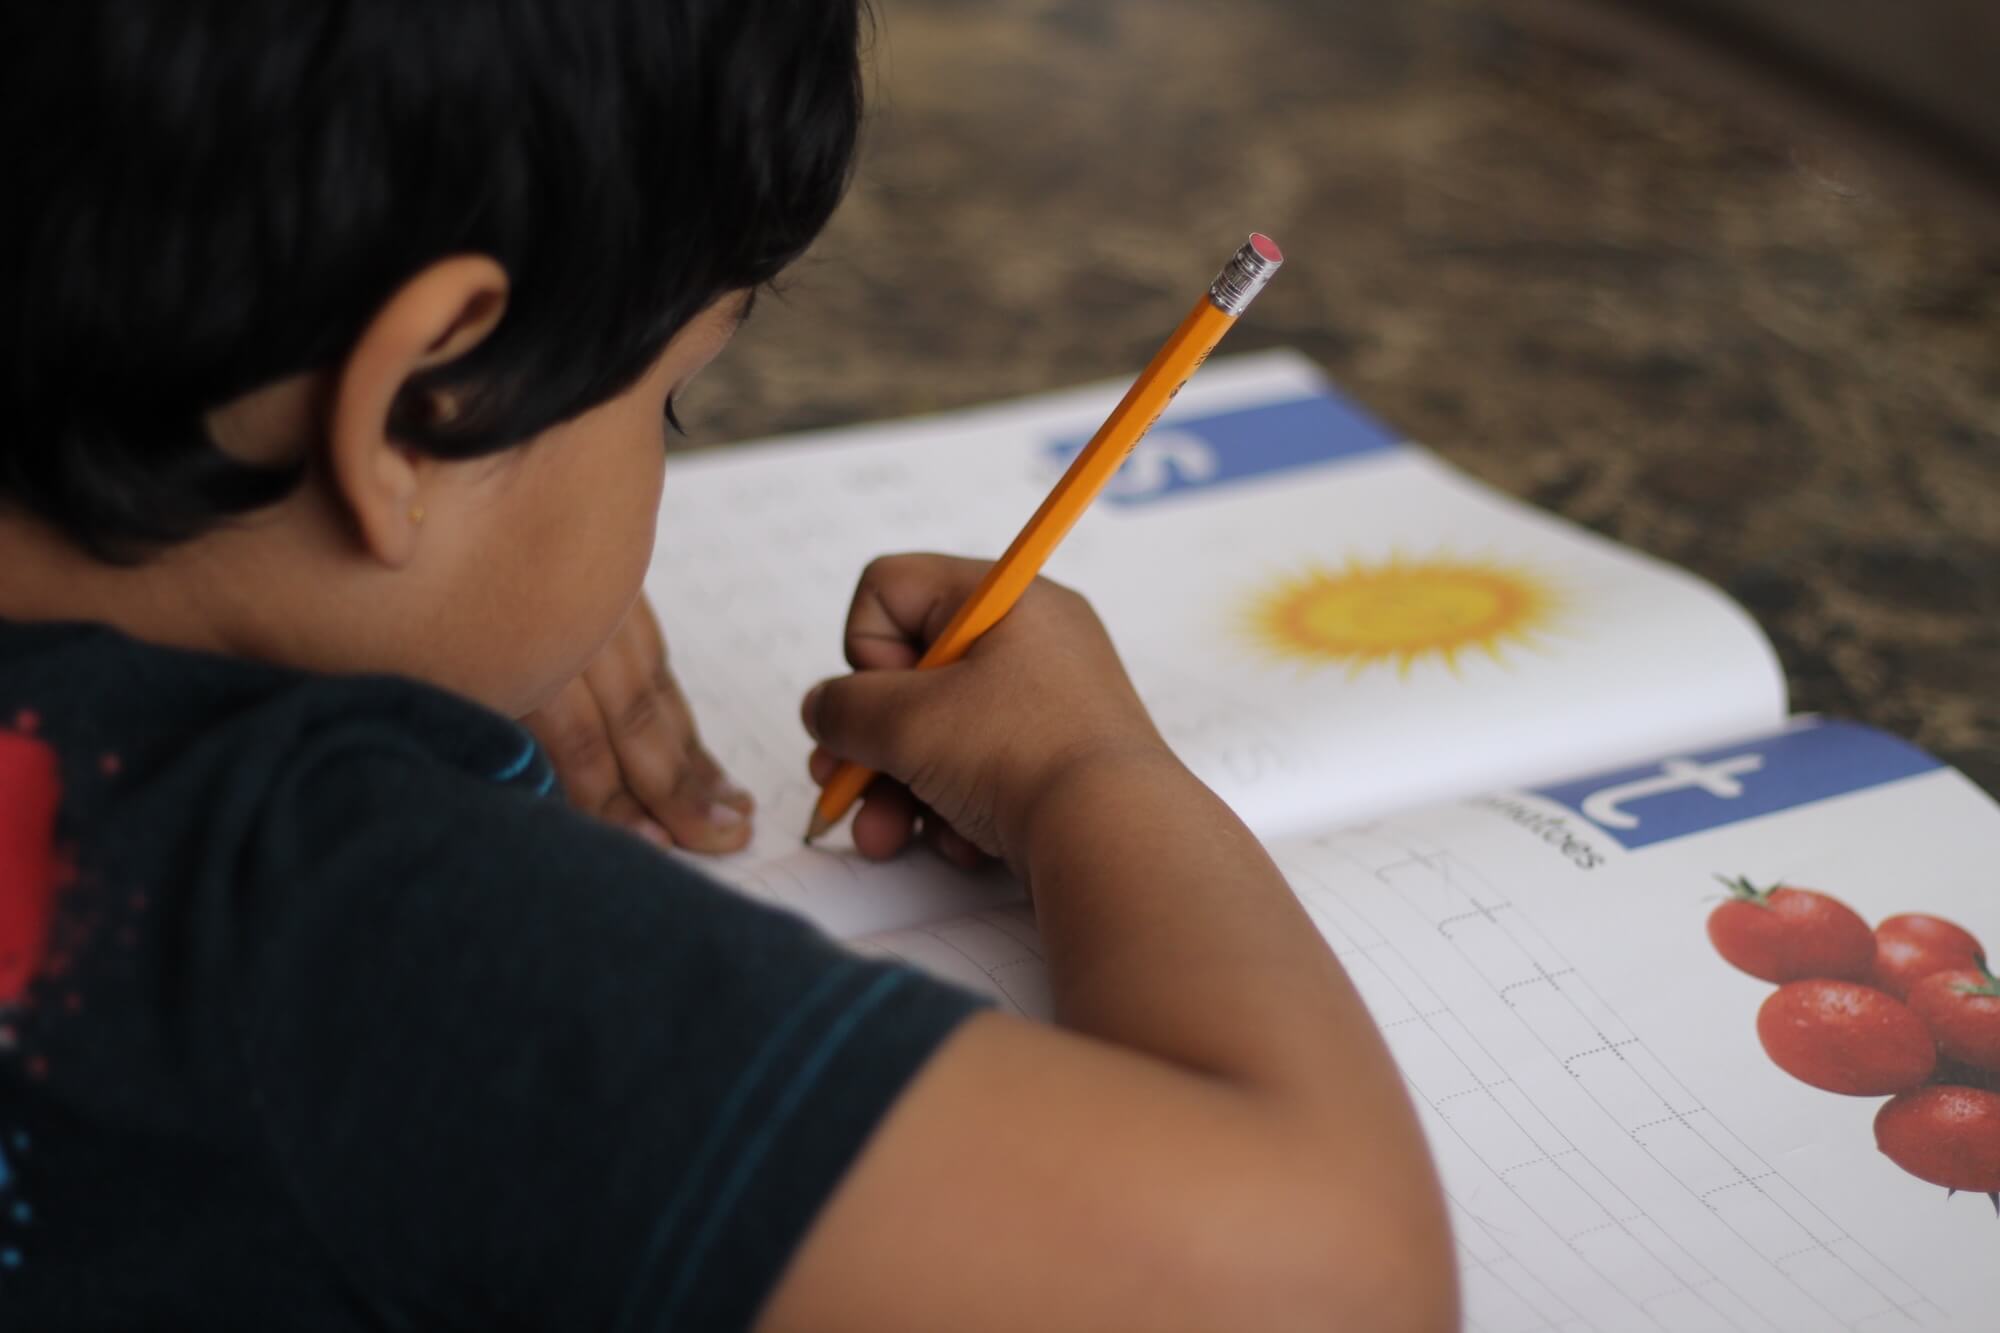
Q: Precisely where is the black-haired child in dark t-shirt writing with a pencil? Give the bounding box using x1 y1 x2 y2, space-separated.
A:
0 0 1454 1333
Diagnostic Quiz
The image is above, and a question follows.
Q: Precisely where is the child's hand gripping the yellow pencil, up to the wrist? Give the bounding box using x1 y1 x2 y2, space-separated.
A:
804 554 1168 873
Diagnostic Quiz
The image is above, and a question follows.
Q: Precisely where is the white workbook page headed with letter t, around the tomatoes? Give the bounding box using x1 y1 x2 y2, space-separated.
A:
860 727 2000 1333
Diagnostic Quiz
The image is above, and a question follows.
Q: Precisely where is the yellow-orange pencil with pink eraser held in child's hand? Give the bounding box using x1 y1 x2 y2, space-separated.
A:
806 232 1284 843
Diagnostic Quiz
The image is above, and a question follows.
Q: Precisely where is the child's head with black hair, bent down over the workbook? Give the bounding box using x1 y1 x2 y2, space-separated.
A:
0 0 860 709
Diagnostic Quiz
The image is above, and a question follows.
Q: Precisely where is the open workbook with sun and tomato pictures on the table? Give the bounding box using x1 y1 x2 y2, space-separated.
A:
648 354 2000 1333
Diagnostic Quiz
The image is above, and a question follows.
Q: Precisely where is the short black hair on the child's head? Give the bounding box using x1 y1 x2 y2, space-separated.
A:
0 0 860 558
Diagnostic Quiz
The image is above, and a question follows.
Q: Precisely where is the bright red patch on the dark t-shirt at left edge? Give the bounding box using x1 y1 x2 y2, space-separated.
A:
0 731 68 1005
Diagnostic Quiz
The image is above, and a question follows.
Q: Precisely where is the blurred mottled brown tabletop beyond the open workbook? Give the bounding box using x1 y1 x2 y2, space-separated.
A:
668 0 2000 793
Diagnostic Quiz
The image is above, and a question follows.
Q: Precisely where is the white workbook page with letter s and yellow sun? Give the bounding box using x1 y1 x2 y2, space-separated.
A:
648 352 1784 933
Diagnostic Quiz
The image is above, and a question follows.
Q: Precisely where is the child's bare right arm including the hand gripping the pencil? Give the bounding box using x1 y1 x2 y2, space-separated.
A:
762 556 1456 1333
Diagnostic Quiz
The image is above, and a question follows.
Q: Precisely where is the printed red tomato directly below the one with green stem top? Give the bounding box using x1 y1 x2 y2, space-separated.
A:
1756 981 1938 1097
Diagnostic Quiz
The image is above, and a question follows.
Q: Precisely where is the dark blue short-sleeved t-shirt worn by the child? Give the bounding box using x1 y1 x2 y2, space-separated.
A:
0 622 976 1333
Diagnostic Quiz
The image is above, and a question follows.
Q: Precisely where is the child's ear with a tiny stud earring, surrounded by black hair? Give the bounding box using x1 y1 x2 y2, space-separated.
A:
326 254 508 568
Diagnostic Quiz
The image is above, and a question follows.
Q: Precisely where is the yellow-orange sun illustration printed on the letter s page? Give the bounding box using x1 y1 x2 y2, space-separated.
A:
1248 554 1564 679
